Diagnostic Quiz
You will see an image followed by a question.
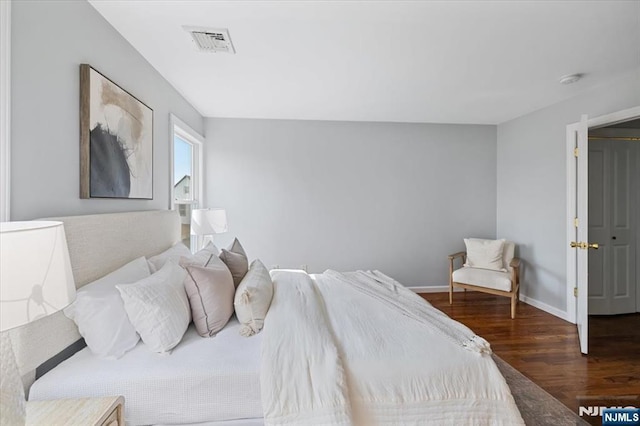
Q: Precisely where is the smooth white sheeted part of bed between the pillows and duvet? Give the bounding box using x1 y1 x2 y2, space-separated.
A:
29 317 262 425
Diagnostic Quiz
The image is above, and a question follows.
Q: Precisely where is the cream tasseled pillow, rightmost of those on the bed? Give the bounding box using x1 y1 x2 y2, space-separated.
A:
233 259 273 337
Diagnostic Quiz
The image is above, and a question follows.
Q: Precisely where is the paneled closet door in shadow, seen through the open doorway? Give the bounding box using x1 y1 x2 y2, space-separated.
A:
589 139 638 315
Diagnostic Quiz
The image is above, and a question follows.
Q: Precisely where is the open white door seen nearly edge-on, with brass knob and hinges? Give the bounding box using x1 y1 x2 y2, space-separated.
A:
567 115 589 354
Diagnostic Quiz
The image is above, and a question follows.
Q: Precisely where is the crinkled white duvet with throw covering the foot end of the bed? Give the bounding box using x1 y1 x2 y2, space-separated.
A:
260 271 524 426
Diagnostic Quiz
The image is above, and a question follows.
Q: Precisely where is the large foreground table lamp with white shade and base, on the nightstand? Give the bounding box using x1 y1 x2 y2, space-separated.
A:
0 221 76 425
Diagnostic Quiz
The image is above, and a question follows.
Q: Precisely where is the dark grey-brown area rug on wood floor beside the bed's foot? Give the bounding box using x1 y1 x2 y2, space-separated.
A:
492 354 589 426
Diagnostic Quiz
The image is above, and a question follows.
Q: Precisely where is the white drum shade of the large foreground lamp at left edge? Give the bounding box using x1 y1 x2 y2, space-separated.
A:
0 221 76 331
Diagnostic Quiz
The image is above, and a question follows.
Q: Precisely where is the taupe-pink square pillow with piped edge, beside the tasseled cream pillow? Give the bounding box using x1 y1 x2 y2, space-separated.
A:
183 256 235 337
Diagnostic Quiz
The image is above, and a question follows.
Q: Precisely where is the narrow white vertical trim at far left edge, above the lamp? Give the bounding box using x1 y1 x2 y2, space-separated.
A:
0 0 11 222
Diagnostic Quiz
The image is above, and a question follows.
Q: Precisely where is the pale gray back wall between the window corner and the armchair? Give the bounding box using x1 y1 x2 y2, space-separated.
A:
205 118 496 286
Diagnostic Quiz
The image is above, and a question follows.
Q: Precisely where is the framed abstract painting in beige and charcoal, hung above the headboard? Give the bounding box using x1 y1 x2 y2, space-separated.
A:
80 64 153 200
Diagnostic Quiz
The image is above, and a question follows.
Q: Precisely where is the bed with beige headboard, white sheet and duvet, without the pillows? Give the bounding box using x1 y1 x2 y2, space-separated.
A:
12 211 523 425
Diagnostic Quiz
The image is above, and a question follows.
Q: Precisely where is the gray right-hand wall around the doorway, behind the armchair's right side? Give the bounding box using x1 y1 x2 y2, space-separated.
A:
497 70 640 311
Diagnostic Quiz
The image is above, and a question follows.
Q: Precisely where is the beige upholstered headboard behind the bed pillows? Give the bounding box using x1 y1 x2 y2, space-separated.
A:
10 210 180 386
